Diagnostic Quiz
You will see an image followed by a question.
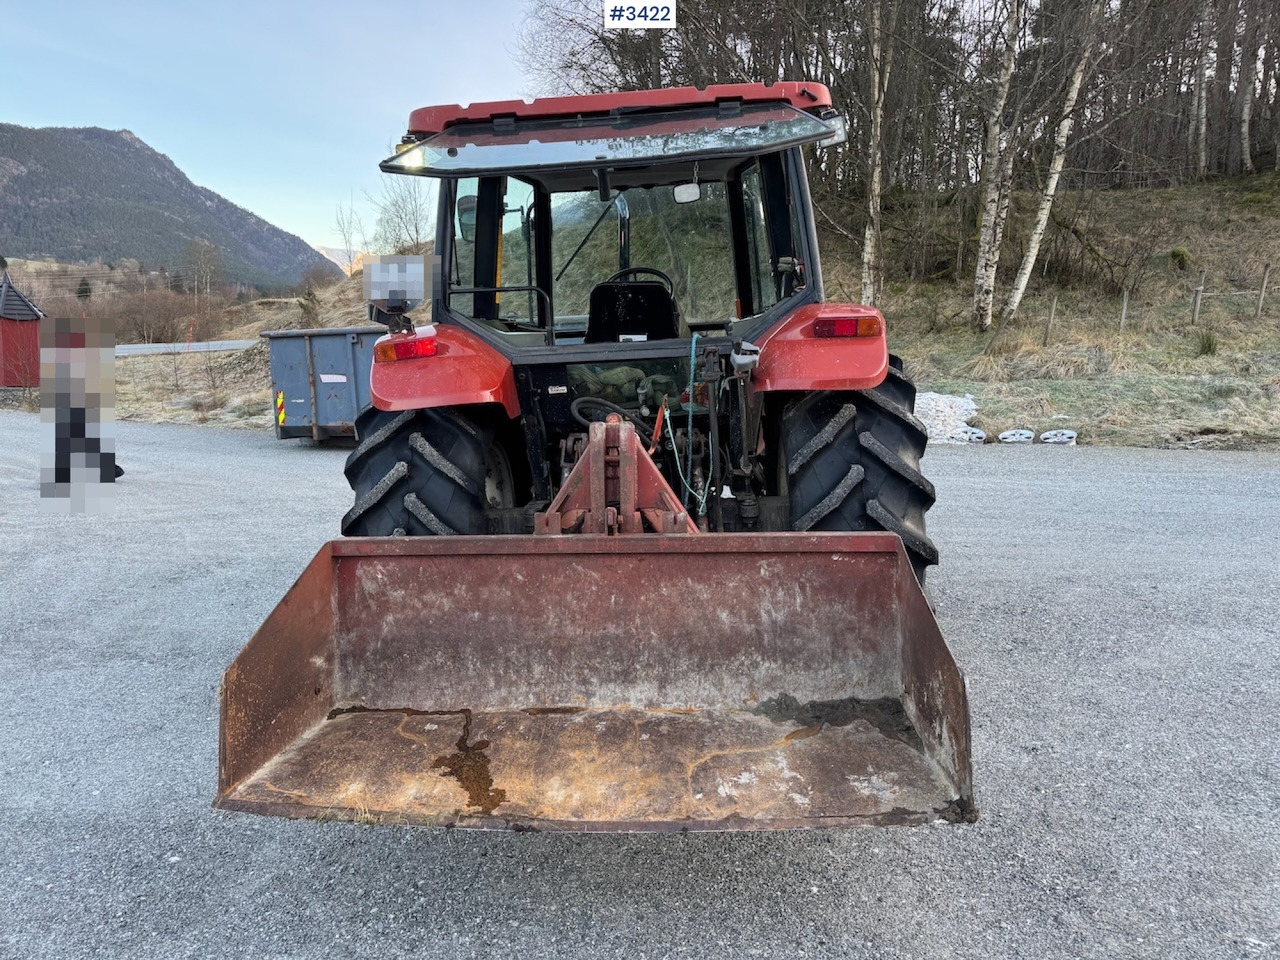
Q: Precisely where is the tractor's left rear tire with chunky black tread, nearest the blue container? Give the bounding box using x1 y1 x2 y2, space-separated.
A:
342 407 511 536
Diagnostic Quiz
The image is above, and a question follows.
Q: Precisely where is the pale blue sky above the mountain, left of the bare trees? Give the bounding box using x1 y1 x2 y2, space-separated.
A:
0 0 534 247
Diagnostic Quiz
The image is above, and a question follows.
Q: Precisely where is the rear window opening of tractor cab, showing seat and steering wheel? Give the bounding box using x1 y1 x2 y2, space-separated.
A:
442 161 803 344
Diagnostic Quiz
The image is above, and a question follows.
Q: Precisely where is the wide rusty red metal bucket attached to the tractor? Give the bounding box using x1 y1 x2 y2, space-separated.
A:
215 532 974 831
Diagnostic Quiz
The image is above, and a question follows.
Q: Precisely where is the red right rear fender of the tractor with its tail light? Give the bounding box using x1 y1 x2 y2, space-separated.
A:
751 303 888 392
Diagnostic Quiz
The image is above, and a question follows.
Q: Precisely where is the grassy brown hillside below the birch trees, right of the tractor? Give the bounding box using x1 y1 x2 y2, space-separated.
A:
823 173 1280 448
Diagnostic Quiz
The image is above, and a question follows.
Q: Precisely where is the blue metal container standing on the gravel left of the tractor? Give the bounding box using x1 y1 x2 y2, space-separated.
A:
261 326 387 443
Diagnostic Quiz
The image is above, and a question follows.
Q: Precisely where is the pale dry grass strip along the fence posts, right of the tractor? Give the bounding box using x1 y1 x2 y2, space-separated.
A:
883 268 1280 448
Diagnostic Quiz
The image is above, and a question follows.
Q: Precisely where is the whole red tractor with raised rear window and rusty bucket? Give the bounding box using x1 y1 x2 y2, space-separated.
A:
216 82 975 831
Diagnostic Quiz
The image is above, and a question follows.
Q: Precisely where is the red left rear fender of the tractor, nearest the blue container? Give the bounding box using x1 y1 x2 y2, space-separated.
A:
369 324 520 417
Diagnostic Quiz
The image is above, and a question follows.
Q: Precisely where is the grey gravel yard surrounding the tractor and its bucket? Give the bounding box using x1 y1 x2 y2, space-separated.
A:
0 411 1280 959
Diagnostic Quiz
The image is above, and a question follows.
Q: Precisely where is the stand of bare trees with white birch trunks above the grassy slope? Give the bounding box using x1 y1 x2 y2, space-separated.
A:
509 0 1280 312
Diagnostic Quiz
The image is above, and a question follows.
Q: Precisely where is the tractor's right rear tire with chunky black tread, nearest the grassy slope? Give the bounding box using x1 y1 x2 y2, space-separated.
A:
782 366 938 585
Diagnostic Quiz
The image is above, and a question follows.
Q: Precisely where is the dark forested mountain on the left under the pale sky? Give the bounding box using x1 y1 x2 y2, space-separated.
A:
0 123 340 289
